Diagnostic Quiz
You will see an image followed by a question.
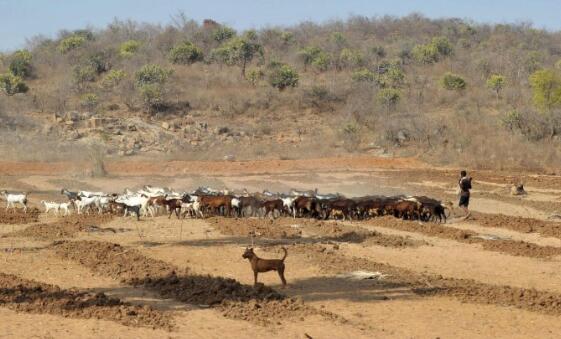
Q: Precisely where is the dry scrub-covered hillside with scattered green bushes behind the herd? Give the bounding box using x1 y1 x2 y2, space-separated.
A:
0 14 561 170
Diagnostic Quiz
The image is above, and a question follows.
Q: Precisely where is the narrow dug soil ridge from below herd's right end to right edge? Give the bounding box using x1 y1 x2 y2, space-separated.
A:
366 216 561 258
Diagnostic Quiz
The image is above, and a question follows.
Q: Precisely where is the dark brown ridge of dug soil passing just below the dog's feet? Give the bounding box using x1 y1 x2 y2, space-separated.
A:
51 241 336 325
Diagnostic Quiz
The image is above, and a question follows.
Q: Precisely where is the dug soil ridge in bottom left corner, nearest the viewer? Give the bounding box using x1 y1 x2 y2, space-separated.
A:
0 273 173 330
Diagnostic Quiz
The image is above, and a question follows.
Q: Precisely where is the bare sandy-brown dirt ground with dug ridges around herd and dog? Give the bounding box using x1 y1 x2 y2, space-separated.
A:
0 157 561 338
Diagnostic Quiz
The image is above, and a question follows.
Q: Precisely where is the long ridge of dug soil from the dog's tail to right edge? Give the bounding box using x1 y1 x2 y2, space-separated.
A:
263 244 561 316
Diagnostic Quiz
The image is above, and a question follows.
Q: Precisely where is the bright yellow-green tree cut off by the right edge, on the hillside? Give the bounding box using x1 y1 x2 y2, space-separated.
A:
529 69 561 111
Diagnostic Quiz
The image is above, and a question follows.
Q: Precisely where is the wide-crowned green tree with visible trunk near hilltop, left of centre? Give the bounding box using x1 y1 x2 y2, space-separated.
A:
211 37 263 78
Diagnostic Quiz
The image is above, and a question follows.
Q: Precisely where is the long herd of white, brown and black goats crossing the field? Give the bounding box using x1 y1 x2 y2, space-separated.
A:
0 186 447 222
